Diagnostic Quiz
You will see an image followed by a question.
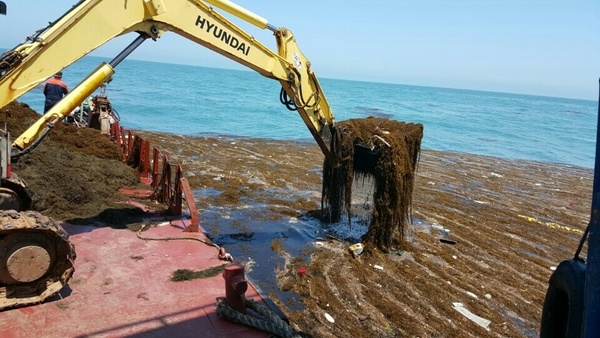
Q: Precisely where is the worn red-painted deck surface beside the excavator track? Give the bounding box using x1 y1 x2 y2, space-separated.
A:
0 221 270 338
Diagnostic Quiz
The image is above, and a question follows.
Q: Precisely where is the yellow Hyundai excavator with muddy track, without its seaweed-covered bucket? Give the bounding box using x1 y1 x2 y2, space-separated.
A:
0 0 354 309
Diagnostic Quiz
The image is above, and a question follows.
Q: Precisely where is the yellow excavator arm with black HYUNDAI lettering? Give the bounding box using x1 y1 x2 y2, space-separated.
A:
0 0 334 156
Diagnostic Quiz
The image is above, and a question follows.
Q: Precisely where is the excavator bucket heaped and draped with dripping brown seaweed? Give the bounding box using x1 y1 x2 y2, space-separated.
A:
322 118 423 252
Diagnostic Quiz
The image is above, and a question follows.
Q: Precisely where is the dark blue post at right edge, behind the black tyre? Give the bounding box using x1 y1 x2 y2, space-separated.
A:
583 81 600 338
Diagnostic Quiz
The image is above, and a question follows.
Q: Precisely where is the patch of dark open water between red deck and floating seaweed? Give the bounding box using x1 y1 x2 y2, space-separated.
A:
200 197 376 310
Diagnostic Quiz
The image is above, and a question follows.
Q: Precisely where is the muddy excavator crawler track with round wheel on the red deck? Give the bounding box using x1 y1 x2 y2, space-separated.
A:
0 210 75 310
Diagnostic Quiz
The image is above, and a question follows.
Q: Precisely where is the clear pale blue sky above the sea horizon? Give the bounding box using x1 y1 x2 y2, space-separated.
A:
0 0 600 100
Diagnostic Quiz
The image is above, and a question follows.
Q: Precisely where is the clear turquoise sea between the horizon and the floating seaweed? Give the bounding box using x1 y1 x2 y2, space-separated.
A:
18 56 598 168
